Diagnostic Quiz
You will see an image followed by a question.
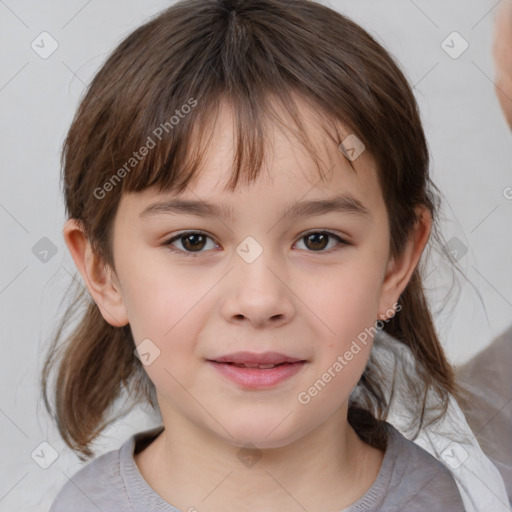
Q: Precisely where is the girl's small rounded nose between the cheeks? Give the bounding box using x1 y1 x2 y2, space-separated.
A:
221 247 295 328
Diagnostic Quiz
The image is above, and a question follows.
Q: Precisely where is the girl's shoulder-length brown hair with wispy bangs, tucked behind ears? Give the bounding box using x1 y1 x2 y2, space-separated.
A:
42 0 464 459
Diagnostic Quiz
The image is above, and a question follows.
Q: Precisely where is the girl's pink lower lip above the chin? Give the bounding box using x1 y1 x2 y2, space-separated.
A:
208 361 306 389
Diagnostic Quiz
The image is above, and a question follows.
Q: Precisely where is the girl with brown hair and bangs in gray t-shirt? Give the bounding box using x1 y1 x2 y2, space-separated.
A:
42 0 496 512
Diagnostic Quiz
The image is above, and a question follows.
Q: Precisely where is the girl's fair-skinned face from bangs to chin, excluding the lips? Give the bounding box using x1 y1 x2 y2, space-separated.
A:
107 100 405 447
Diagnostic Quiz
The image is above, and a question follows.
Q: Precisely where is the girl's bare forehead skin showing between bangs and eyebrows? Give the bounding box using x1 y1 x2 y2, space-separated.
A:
115 98 382 219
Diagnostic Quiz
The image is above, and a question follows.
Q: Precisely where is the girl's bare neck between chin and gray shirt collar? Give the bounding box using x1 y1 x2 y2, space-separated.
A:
135 410 383 512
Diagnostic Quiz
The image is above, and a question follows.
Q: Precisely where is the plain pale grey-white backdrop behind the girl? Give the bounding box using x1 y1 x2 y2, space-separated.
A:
0 0 512 511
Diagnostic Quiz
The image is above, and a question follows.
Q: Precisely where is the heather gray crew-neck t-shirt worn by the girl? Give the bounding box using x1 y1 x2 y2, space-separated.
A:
49 423 464 512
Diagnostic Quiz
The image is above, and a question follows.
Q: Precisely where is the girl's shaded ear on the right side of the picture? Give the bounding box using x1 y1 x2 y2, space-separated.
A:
379 206 432 320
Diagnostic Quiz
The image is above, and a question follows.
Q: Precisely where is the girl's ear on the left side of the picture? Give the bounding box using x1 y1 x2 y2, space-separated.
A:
62 219 128 327
